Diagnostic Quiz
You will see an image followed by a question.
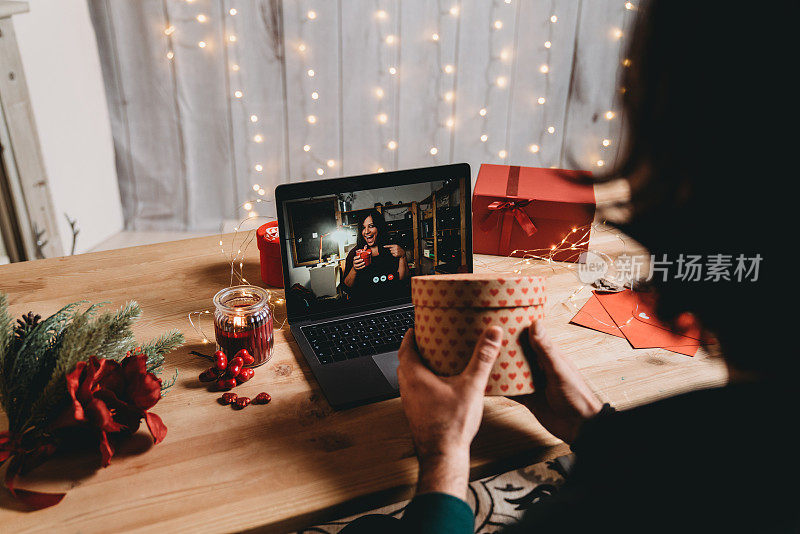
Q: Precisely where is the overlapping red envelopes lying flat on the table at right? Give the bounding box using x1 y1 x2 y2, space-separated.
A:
571 291 700 356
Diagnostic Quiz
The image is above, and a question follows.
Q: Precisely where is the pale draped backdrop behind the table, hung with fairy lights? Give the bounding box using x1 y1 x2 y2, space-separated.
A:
89 0 636 231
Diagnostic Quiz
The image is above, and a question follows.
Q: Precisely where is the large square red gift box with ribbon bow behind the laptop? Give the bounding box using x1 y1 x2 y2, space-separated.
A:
472 163 595 262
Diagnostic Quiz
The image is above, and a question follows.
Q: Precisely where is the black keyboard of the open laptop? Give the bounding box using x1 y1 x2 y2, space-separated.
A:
301 308 414 364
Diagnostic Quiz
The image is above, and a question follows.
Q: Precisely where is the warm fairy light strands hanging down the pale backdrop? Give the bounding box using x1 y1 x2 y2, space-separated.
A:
163 0 636 207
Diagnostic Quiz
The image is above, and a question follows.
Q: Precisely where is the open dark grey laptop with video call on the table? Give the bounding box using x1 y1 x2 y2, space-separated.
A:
275 164 472 409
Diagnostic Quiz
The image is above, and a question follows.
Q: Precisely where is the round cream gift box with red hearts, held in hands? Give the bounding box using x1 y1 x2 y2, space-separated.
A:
411 274 546 395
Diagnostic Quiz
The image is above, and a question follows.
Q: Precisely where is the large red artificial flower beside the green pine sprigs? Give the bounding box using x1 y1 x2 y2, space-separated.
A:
59 354 167 467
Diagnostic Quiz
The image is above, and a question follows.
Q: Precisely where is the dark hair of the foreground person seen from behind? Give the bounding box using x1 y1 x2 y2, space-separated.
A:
606 0 797 373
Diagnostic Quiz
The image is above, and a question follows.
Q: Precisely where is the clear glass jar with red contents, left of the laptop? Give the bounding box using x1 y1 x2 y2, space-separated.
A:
214 286 273 367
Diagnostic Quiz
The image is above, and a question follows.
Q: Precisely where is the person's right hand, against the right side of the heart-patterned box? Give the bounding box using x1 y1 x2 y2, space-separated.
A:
513 321 603 443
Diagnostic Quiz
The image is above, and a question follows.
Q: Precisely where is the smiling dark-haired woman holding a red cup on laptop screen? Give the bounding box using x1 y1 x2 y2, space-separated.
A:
344 210 409 302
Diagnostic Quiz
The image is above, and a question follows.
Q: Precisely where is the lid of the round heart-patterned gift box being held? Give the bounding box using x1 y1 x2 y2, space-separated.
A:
411 273 546 308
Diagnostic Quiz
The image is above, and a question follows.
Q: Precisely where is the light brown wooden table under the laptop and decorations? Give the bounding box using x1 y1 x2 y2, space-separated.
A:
0 228 727 532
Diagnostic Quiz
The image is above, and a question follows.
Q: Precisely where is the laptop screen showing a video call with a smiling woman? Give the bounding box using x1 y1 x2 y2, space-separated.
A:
278 165 472 321
